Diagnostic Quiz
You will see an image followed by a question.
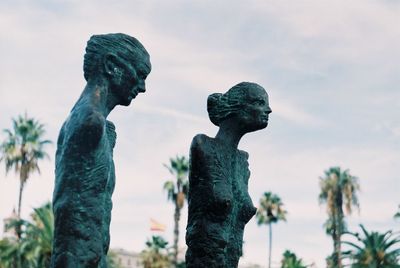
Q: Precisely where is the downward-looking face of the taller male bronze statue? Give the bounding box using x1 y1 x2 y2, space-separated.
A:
112 57 151 106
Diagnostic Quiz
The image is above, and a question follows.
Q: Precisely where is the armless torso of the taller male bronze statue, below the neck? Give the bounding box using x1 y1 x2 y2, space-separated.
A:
53 105 116 267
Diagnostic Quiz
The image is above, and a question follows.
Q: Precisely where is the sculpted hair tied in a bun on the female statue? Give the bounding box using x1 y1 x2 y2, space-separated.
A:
207 82 261 126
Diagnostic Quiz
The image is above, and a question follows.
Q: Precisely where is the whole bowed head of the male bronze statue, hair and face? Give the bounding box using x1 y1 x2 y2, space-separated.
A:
83 33 151 106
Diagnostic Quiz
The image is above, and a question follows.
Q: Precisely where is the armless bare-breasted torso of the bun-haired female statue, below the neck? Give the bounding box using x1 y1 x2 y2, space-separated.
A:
187 135 256 267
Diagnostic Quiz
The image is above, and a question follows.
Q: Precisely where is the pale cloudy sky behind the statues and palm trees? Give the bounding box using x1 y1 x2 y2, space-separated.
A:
0 0 400 267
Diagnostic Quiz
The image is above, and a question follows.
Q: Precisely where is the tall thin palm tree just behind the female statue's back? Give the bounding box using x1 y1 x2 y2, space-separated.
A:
164 156 189 266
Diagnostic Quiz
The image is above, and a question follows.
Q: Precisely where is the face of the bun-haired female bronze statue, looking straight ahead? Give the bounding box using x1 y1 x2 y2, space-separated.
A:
239 87 272 132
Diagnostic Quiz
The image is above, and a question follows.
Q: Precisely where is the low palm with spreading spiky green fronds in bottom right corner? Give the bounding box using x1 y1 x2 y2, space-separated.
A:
343 224 400 268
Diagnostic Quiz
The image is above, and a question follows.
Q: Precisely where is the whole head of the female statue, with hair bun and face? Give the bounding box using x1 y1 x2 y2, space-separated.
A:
207 82 272 132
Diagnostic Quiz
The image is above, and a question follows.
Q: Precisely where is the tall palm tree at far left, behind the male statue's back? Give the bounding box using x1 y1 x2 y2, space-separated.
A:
0 113 51 220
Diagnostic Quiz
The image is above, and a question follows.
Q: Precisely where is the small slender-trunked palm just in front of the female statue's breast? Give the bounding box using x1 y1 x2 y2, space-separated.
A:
256 192 287 268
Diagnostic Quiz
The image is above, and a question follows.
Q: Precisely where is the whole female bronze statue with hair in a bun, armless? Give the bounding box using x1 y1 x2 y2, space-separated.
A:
186 82 271 268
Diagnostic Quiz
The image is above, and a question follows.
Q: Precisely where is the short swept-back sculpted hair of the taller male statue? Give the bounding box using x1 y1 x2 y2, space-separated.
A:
83 33 149 81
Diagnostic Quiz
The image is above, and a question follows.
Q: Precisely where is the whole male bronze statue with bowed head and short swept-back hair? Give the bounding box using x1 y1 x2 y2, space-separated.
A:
51 34 151 268
